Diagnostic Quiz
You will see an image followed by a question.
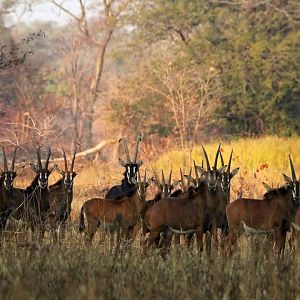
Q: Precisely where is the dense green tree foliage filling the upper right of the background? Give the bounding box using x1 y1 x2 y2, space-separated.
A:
112 0 300 136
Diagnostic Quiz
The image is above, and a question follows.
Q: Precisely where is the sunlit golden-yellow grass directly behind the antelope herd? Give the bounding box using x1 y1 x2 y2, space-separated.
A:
13 136 300 218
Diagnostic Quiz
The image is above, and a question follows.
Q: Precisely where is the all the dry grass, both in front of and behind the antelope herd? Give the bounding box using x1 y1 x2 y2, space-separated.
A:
0 137 300 299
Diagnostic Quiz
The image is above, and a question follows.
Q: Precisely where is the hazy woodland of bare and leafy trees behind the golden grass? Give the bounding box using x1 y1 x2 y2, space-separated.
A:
0 0 300 159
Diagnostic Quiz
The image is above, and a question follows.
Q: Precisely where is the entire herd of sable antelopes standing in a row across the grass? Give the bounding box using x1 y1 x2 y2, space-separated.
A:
0 136 300 255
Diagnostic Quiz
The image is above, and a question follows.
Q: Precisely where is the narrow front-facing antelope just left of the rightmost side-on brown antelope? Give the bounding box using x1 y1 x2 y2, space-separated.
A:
217 150 240 236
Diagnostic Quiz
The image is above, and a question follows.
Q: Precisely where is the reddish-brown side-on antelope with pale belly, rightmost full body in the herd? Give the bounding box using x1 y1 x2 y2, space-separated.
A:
226 156 300 254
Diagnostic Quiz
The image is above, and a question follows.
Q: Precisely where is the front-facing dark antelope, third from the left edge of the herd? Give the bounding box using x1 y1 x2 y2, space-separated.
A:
49 147 82 238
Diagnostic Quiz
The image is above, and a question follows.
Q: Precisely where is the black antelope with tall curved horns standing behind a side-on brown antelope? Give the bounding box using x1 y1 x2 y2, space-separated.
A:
105 135 143 199
